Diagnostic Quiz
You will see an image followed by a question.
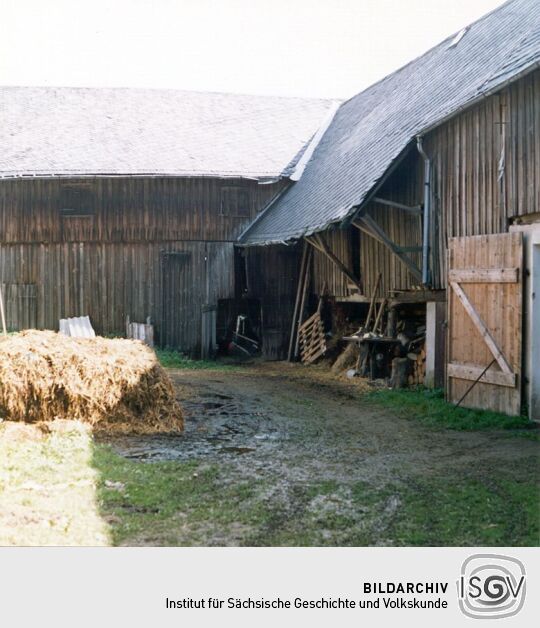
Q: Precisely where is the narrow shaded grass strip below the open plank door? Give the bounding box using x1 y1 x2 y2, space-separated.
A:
366 389 537 437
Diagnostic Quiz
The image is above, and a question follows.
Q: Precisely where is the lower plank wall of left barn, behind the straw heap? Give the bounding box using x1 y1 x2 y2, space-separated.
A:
0 242 234 354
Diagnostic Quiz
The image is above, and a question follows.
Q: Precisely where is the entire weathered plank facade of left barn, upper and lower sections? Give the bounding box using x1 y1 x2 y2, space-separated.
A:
0 179 280 355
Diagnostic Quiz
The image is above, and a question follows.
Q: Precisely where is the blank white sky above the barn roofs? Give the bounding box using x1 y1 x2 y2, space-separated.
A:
0 0 502 97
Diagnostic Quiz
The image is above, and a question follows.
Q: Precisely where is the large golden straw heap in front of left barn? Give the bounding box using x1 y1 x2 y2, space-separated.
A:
0 330 183 434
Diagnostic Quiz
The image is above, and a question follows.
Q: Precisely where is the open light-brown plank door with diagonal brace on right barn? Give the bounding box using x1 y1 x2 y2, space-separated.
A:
447 233 523 415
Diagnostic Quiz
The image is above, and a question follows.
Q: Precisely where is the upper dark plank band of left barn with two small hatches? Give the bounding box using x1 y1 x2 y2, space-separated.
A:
0 178 283 244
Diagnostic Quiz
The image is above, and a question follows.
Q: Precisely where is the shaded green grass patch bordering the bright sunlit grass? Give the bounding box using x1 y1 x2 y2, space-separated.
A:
94 445 266 546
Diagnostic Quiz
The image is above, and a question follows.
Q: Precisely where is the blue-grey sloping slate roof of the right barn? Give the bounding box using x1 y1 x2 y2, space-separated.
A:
241 0 540 244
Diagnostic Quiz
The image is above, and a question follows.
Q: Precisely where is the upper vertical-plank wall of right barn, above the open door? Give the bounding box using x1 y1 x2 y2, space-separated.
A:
426 71 540 287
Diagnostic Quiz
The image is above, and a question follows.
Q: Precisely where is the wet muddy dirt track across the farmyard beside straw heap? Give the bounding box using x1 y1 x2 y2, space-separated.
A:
108 364 538 483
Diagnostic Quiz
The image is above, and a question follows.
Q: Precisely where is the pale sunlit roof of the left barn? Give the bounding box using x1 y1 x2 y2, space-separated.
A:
0 87 332 179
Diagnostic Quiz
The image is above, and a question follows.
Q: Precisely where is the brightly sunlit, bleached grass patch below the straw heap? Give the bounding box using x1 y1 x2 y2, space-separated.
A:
0 421 110 546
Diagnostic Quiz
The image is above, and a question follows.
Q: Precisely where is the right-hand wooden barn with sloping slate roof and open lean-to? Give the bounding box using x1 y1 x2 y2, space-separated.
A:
241 0 540 419
